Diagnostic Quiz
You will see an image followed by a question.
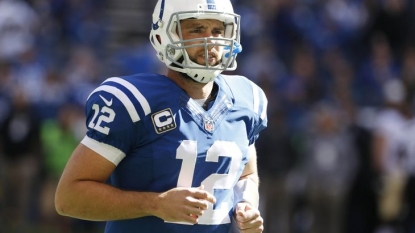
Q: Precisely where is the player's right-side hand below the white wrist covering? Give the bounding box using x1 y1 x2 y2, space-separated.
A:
234 202 264 233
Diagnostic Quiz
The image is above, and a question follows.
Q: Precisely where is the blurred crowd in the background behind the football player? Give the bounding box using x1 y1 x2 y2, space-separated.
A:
0 0 415 233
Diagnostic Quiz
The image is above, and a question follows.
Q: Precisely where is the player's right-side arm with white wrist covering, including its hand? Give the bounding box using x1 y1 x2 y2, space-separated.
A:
234 145 264 233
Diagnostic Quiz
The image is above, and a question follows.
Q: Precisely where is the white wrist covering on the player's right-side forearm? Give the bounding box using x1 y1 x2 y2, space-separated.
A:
233 178 259 209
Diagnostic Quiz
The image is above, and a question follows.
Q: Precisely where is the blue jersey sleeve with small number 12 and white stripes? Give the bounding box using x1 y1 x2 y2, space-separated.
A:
81 78 148 165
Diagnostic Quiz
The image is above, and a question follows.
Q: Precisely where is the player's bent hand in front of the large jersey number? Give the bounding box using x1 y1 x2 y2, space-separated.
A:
155 185 216 224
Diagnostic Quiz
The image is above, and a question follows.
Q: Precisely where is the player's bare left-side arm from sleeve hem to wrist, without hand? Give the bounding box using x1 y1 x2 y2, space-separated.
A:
55 143 151 220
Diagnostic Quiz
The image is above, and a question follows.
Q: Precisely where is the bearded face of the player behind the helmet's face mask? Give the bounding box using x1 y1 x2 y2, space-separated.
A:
180 19 225 66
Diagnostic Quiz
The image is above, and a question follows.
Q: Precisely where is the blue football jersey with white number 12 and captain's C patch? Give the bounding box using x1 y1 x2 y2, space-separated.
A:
82 74 267 233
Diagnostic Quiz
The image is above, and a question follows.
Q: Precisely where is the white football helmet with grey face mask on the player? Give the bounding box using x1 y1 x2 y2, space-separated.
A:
150 0 242 83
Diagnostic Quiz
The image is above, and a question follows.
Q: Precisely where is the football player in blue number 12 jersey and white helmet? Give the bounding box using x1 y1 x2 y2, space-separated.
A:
55 0 267 233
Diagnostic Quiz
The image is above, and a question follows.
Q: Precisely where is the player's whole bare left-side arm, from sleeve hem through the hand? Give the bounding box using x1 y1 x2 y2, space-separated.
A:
55 140 214 223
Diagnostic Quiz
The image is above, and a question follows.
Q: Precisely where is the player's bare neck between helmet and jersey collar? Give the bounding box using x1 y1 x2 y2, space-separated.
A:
167 70 213 99
